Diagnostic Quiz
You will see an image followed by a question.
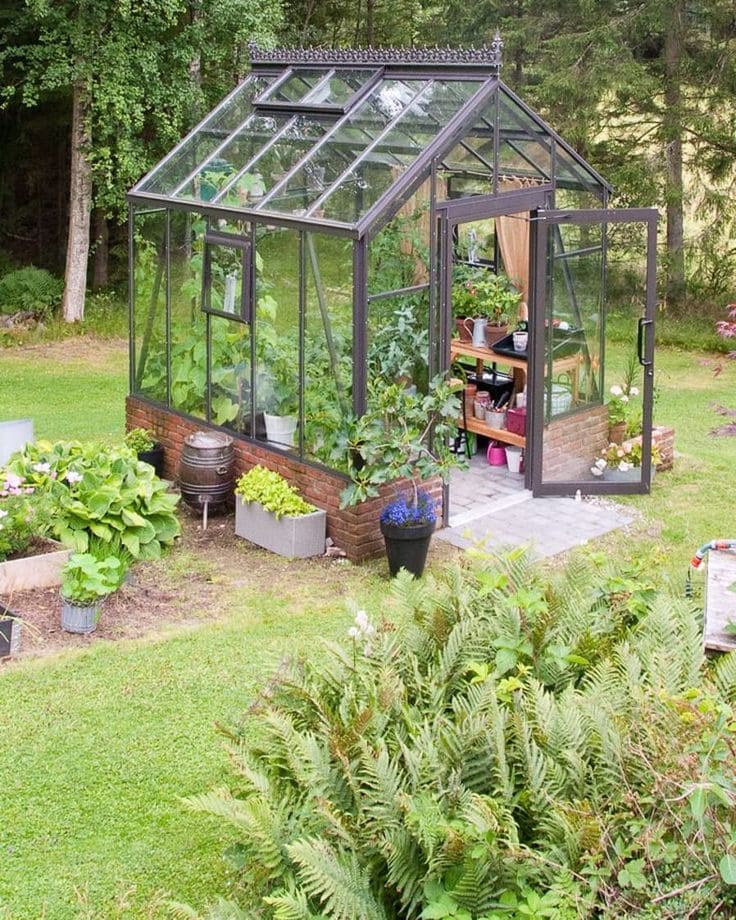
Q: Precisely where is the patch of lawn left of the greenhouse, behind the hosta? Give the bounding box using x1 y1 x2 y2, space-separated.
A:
0 340 128 440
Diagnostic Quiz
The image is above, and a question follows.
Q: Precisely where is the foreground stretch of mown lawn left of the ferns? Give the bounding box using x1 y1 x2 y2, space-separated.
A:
0 584 392 920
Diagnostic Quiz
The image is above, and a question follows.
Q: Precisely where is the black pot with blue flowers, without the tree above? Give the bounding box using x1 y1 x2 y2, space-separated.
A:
381 490 437 578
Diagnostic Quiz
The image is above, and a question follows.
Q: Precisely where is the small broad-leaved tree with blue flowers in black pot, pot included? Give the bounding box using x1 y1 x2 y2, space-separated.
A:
342 376 466 576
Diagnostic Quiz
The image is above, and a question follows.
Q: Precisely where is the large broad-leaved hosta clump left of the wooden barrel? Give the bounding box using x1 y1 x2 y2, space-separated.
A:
0 441 180 559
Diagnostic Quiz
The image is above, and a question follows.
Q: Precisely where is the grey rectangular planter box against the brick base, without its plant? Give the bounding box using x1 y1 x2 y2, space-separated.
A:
235 496 327 559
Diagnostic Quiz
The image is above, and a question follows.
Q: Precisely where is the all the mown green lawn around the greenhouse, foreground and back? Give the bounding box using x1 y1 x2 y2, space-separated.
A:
0 339 736 920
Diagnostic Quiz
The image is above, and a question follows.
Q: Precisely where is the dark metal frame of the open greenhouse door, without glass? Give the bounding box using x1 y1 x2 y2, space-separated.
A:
527 208 658 496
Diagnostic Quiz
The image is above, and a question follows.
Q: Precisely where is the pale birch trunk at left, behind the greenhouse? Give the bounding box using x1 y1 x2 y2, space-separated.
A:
61 82 92 323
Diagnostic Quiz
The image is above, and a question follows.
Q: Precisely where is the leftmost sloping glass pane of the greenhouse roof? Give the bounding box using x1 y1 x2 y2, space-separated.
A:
141 77 272 195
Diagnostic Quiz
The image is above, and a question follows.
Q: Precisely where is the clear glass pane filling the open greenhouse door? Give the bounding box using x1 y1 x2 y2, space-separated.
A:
542 217 647 484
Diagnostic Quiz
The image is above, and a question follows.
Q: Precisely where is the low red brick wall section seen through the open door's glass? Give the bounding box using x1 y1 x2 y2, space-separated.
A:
543 406 608 482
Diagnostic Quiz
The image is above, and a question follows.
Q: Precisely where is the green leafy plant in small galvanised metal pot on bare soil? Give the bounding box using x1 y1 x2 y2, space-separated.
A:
61 553 125 634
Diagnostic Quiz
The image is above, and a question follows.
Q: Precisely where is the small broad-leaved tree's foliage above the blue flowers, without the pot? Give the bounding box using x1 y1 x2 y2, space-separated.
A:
341 376 464 507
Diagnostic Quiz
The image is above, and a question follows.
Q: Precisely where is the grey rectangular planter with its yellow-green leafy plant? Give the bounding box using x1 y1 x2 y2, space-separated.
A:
235 466 327 559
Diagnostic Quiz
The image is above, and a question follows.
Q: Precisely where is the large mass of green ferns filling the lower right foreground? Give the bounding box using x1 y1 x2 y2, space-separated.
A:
191 554 736 920
